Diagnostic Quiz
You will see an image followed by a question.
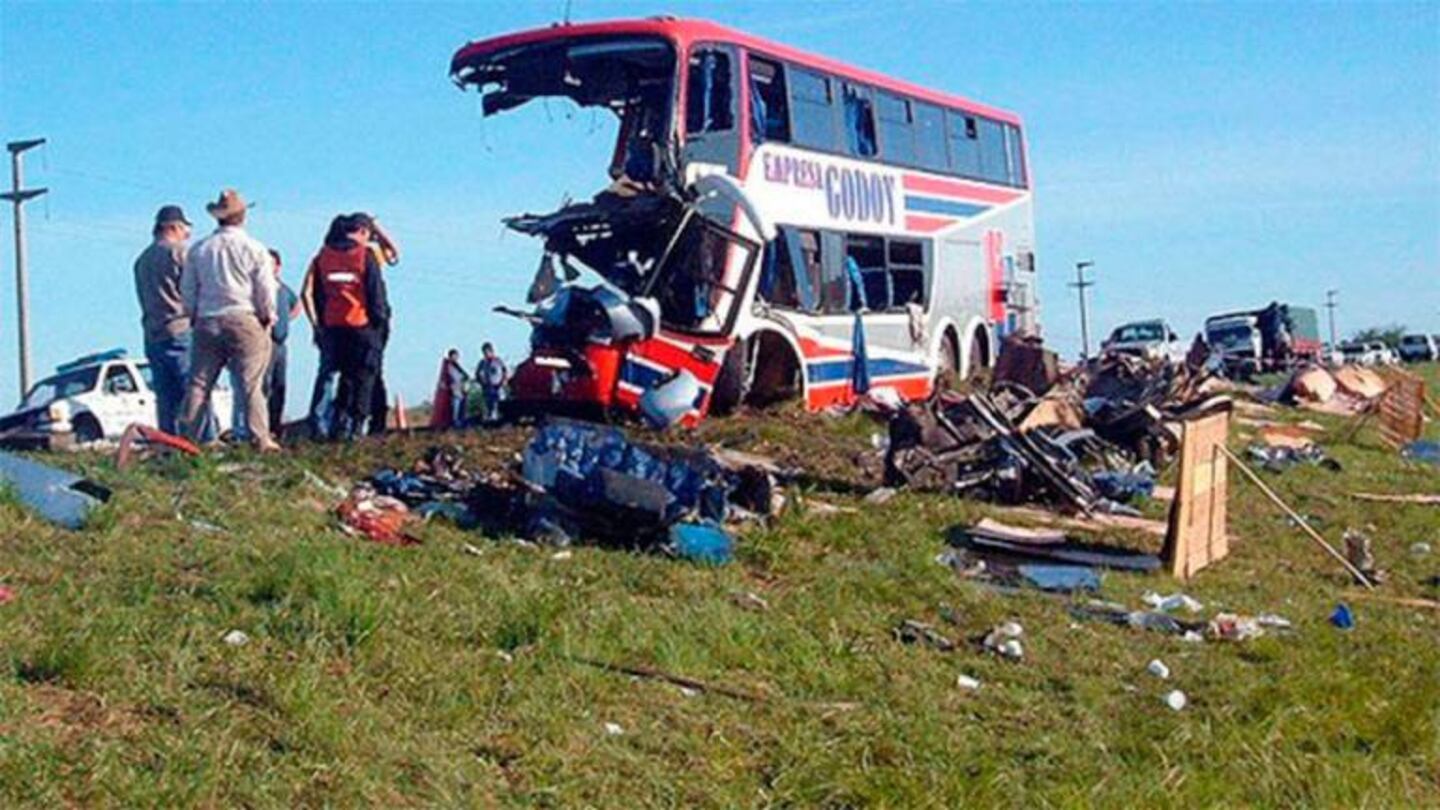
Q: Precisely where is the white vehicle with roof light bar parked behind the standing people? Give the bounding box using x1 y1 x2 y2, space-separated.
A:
0 349 232 450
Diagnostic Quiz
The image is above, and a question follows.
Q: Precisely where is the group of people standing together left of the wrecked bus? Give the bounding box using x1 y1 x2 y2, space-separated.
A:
134 189 399 451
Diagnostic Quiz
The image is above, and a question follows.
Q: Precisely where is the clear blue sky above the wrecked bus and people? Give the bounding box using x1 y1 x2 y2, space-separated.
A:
0 0 1440 414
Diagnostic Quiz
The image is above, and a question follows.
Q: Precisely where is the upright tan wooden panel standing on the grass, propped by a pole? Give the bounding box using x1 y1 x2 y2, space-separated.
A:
1161 411 1230 579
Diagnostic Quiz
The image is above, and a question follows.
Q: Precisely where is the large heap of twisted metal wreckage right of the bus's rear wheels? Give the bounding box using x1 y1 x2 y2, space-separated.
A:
886 340 1228 515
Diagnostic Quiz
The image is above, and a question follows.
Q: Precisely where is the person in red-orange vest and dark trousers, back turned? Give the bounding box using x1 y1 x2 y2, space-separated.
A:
311 216 390 441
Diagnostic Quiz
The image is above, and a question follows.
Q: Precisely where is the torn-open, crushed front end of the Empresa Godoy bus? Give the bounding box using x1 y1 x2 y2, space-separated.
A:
451 26 766 422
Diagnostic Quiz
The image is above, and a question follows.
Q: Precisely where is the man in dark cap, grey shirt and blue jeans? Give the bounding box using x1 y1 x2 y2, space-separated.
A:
135 205 190 434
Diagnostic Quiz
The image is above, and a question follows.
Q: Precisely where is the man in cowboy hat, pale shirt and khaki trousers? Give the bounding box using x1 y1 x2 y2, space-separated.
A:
180 189 279 451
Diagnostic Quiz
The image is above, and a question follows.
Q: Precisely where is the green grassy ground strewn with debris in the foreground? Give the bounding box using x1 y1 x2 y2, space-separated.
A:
0 368 1440 807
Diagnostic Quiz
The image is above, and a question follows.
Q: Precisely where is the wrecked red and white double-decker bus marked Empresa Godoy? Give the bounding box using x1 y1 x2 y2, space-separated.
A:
451 17 1037 421
